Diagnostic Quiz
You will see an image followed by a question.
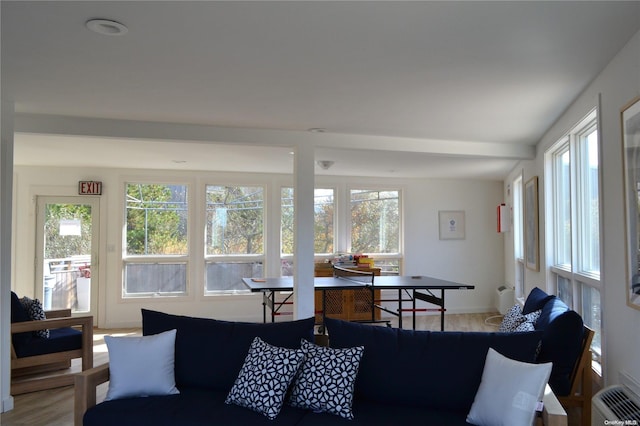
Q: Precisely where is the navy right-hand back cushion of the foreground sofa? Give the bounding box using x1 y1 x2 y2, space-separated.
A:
326 318 542 412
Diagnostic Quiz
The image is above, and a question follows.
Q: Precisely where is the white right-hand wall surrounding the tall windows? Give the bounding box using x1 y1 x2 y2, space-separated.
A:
505 29 640 384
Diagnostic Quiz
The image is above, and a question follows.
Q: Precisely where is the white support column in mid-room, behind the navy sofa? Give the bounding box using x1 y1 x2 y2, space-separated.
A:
293 143 315 319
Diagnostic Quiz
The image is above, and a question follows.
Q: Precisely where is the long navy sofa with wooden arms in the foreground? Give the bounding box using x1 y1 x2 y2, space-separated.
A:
76 310 566 426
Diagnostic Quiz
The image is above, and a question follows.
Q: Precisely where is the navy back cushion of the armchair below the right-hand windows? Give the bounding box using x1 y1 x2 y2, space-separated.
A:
536 296 584 396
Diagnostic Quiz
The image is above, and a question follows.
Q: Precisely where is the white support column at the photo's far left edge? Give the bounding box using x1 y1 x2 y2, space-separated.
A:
0 102 13 413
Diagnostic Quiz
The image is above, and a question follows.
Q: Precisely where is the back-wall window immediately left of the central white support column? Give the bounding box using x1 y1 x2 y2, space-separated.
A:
205 185 264 293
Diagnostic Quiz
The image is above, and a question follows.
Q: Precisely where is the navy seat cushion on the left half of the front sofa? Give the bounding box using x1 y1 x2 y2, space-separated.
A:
84 388 310 426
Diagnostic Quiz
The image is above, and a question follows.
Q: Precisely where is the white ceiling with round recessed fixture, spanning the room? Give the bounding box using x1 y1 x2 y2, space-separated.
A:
1 1 640 179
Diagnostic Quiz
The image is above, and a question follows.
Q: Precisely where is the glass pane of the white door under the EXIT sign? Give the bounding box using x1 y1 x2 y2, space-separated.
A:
43 204 92 312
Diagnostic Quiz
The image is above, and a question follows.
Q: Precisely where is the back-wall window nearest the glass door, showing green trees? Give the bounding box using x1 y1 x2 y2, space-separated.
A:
123 183 189 297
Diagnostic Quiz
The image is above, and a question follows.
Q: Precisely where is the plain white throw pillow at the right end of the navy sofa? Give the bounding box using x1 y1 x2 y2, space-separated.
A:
467 348 551 426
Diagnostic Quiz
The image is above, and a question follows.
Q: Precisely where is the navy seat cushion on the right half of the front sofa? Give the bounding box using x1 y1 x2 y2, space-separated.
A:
298 400 468 426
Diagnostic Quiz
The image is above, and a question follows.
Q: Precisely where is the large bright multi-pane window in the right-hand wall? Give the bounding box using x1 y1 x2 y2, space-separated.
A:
546 111 602 370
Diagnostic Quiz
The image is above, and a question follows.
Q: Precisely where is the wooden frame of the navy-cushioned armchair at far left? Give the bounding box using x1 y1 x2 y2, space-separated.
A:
11 294 93 395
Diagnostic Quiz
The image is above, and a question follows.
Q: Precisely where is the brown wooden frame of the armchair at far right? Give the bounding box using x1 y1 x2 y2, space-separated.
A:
558 326 595 426
